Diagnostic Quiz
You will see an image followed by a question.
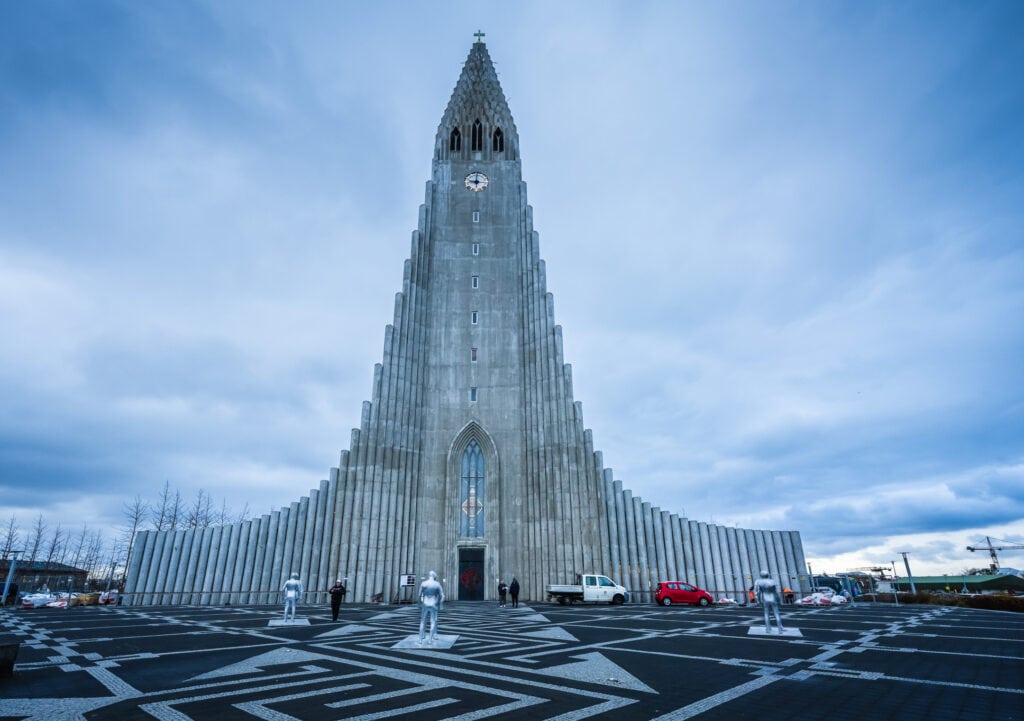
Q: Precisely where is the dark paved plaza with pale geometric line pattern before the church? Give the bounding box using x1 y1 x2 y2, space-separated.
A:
0 601 1024 721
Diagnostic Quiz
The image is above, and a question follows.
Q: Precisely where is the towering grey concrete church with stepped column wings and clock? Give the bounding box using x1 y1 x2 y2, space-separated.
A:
125 42 806 604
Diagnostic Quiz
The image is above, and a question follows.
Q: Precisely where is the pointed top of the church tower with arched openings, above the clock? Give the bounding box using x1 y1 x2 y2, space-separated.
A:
434 38 519 161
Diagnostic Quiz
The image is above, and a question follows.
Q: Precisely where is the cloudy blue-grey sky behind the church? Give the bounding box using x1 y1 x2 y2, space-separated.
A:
0 0 1024 574
